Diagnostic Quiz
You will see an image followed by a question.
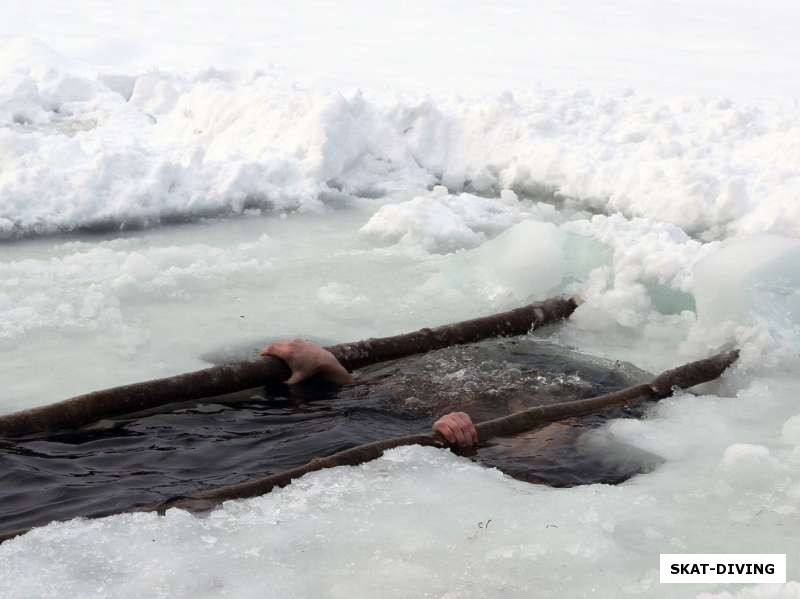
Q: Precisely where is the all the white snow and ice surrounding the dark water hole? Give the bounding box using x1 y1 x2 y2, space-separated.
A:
0 0 800 599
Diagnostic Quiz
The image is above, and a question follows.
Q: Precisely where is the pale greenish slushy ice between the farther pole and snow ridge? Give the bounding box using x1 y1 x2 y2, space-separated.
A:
0 198 602 412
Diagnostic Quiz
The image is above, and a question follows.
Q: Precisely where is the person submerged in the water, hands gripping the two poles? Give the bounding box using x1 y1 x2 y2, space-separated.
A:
260 339 643 447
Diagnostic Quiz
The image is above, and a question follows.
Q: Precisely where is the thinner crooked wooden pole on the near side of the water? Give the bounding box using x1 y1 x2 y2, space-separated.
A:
0 350 739 543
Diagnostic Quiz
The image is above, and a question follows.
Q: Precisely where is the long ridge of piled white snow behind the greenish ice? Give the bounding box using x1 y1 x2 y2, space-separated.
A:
0 39 800 240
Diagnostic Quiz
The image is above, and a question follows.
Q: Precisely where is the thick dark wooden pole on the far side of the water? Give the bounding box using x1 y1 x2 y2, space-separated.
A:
0 297 577 435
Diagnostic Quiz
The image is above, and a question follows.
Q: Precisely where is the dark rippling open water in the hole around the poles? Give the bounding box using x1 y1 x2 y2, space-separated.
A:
0 338 664 534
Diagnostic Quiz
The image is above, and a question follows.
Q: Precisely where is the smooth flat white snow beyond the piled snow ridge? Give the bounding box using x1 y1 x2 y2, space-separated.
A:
0 0 800 98
